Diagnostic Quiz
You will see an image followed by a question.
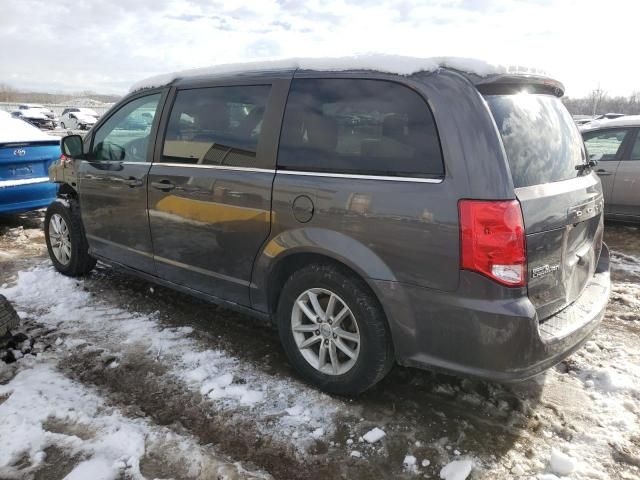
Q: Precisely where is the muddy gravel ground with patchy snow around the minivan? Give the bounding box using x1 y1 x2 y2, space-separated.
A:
0 212 640 480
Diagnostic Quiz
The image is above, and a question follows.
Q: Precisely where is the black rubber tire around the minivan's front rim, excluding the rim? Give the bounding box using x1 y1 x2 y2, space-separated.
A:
44 198 96 277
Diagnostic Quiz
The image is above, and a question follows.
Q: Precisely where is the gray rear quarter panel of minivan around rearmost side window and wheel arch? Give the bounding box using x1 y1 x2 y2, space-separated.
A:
251 70 530 360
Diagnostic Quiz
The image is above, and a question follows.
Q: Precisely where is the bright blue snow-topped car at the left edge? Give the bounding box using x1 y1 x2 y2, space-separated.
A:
0 112 61 214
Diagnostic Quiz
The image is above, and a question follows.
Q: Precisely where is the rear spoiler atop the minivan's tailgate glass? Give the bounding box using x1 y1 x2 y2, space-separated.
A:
473 74 564 97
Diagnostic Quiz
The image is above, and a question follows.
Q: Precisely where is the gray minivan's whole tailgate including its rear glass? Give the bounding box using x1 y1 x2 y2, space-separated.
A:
485 93 603 320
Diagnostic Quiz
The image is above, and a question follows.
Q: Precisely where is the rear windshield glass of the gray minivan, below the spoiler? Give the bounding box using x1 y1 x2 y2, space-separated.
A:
485 94 585 188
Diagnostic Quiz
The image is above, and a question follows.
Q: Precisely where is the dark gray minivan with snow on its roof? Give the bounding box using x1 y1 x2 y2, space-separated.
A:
45 60 610 394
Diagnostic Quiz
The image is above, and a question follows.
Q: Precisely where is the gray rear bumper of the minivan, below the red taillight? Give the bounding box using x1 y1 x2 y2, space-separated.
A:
375 245 611 382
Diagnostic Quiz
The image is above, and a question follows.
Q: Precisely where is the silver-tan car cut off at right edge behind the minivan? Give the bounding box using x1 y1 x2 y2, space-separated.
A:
581 115 640 222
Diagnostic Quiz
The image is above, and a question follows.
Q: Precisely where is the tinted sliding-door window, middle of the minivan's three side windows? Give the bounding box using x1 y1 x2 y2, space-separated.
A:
162 85 271 167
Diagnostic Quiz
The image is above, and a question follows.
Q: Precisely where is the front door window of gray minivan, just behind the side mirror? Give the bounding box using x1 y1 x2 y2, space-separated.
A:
91 93 161 162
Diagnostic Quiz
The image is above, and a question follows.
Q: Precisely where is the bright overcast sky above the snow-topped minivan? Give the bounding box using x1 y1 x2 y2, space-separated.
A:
0 0 640 96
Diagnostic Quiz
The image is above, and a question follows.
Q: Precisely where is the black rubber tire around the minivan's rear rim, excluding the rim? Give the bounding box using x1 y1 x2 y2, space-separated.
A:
277 264 395 396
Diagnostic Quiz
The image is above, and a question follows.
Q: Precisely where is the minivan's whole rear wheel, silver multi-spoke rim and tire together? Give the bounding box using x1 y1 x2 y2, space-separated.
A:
277 265 394 395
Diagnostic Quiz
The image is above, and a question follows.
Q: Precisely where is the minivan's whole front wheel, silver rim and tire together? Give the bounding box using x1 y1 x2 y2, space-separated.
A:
44 198 96 277
